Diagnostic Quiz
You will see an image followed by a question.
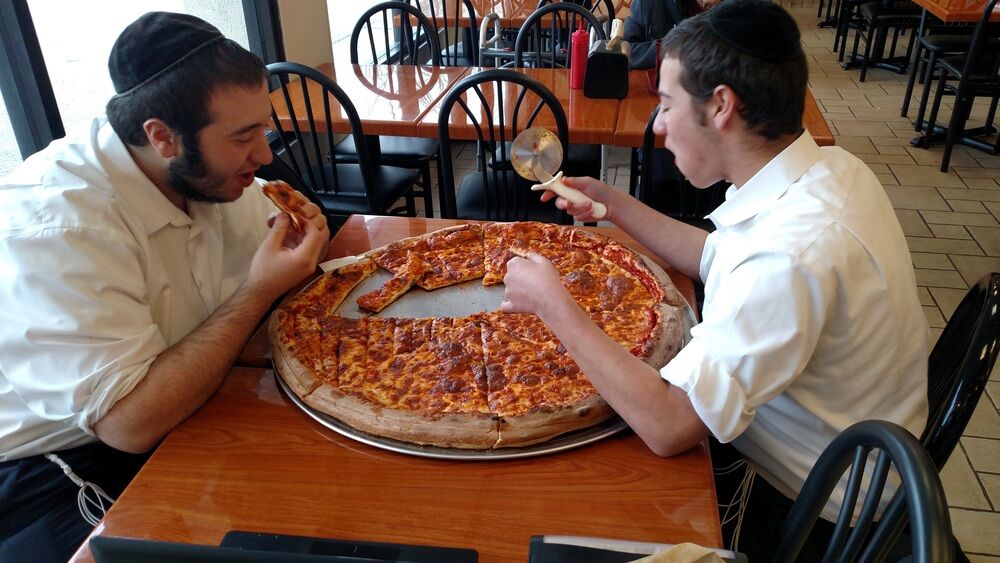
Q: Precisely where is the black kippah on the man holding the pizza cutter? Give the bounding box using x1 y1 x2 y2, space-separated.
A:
706 0 802 62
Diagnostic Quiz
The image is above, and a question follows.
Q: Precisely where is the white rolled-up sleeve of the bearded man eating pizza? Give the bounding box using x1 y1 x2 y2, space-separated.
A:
0 228 167 434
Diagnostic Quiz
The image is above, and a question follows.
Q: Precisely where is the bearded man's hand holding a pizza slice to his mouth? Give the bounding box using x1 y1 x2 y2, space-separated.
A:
247 213 329 299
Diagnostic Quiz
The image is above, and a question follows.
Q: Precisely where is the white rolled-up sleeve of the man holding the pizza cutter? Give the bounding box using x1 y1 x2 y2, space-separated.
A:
660 253 830 442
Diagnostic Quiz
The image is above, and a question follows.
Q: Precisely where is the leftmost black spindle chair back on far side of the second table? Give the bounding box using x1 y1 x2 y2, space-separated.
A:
350 1 441 66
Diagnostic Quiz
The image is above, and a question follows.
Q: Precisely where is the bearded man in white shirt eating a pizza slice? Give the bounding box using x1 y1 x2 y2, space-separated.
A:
0 12 329 561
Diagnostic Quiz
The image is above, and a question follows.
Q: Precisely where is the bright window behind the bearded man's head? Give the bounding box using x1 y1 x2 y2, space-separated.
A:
0 0 284 177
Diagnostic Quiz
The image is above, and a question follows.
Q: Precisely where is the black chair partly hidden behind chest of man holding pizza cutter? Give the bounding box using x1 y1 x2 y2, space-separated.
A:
635 106 728 226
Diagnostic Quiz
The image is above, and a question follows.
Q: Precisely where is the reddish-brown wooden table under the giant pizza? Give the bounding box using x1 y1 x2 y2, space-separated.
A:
73 216 721 563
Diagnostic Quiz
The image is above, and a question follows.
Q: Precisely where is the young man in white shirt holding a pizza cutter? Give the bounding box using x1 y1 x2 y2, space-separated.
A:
502 0 928 561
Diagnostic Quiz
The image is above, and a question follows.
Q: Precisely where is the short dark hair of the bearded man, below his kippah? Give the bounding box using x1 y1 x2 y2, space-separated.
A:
105 39 267 146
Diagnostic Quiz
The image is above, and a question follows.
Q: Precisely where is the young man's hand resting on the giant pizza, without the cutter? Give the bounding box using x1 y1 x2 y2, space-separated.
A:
500 252 572 316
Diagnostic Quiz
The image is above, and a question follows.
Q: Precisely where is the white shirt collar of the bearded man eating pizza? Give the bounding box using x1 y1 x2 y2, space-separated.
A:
98 121 193 235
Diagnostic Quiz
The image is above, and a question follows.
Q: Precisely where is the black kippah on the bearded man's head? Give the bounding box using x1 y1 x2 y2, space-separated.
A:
108 12 225 96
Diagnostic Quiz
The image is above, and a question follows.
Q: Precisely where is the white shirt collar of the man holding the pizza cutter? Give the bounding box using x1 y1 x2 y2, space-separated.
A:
708 132 820 227
